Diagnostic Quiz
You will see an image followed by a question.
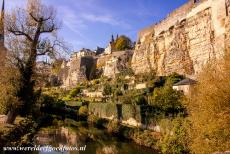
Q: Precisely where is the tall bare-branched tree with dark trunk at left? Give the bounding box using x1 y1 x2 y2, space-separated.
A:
5 0 62 123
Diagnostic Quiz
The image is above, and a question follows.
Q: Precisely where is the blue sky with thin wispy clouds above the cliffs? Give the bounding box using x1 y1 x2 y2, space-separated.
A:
5 0 188 51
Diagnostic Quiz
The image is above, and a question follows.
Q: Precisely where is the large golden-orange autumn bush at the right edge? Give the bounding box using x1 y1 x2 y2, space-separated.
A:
185 55 230 153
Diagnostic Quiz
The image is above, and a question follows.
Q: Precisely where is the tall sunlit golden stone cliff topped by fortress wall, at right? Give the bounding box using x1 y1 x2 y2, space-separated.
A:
132 0 229 75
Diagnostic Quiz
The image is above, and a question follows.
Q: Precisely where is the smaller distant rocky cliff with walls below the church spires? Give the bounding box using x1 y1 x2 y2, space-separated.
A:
58 50 133 88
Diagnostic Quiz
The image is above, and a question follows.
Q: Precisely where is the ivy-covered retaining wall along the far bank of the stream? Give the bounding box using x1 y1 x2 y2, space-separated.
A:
88 103 156 130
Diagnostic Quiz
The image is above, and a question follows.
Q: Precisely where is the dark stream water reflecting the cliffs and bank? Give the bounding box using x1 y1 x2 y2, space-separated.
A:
35 127 156 154
